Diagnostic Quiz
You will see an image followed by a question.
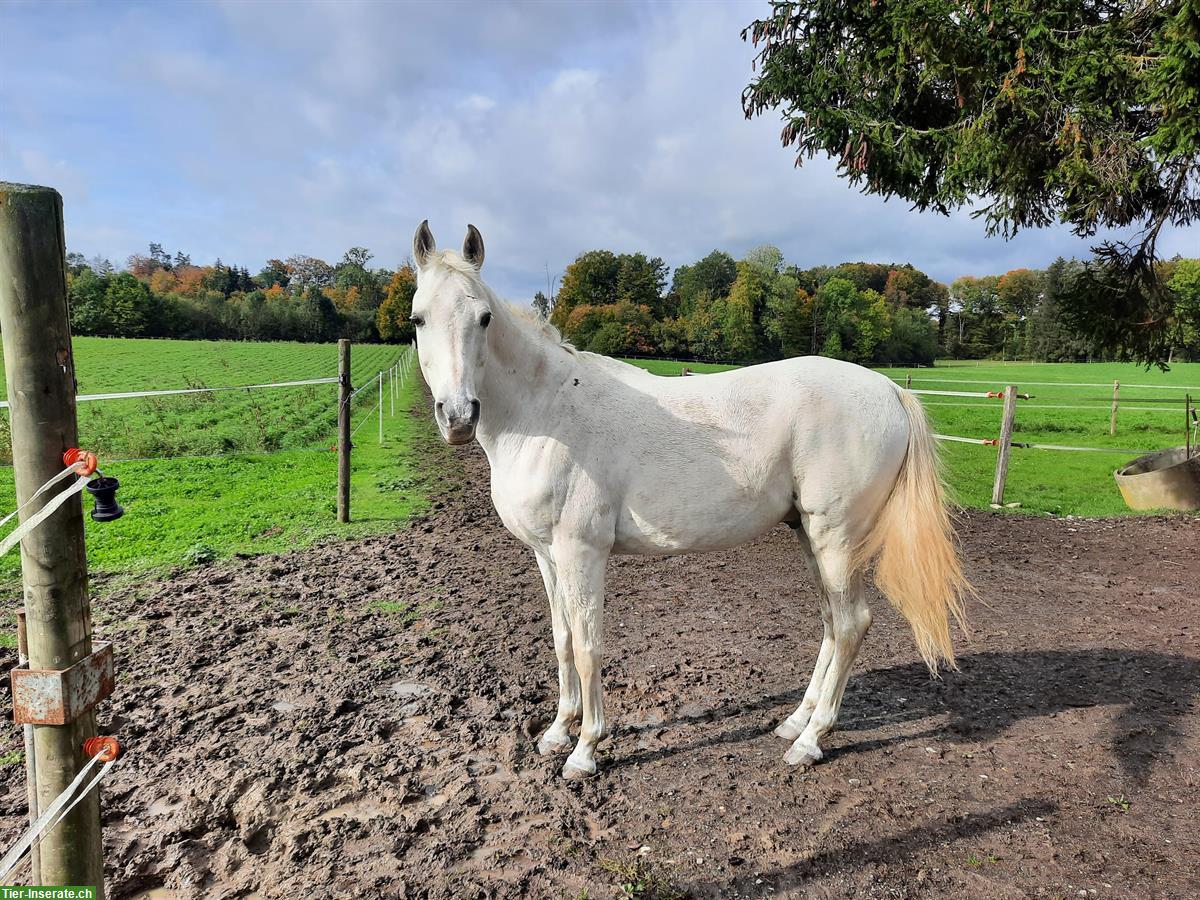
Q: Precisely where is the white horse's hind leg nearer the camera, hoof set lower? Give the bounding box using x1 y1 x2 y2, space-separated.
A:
784 522 871 766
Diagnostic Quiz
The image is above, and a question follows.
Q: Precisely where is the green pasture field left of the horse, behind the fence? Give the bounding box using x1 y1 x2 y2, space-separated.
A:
0 337 436 590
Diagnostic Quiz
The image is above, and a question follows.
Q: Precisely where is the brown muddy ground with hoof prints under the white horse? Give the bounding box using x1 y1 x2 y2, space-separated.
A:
0 412 1200 898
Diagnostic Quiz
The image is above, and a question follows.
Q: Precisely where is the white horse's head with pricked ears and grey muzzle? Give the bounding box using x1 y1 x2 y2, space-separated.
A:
412 221 492 444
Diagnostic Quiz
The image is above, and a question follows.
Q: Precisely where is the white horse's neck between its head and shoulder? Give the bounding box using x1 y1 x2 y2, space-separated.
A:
478 310 575 453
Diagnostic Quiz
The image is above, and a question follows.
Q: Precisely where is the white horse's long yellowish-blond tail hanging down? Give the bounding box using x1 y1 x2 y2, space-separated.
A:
854 390 974 676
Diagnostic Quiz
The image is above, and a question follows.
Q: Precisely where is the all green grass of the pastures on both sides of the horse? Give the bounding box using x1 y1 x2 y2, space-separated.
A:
0 337 1200 595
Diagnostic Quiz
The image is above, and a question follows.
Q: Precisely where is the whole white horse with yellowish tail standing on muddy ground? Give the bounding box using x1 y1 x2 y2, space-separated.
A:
412 222 971 778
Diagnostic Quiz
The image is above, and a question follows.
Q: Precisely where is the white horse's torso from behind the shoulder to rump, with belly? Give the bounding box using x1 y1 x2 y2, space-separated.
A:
578 358 907 553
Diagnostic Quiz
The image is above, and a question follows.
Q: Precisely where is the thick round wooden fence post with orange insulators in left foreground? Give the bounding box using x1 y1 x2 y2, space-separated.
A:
0 182 104 896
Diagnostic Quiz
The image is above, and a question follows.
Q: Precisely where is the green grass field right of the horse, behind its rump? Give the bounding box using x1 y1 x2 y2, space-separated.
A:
629 360 1200 516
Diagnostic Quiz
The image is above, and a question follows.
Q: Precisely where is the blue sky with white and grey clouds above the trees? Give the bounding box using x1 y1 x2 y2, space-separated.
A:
0 0 1200 299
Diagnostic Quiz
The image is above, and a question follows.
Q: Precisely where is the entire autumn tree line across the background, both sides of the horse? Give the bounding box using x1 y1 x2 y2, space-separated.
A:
67 244 1200 365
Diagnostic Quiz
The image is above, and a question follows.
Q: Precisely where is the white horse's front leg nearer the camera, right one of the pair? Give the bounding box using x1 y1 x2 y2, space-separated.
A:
554 542 608 779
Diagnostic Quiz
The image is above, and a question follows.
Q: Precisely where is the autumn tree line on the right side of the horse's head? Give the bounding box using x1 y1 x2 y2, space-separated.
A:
549 246 1200 365
